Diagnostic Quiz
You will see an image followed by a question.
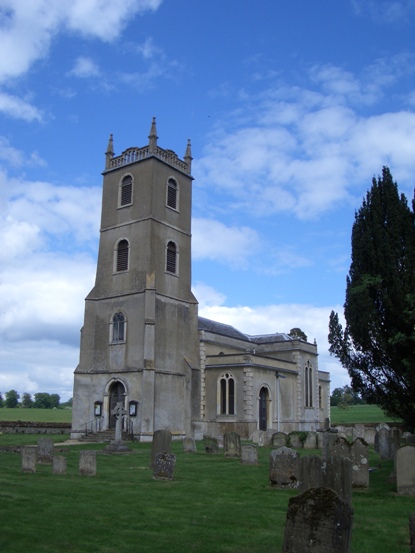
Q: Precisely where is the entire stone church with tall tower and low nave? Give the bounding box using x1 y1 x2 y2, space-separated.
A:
71 118 330 441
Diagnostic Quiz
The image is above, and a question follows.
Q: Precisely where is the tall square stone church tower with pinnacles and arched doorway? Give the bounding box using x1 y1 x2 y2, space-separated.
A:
72 119 200 441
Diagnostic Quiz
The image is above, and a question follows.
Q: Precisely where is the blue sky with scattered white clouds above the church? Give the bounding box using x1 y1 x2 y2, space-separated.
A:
0 0 415 400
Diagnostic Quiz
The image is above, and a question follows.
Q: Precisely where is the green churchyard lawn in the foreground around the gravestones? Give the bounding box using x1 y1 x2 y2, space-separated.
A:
0 434 414 553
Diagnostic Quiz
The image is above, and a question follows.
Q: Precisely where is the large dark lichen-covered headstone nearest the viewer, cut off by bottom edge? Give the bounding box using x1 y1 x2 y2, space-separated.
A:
282 488 353 553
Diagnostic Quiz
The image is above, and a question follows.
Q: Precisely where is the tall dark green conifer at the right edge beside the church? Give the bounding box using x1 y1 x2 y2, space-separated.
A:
328 167 415 427
